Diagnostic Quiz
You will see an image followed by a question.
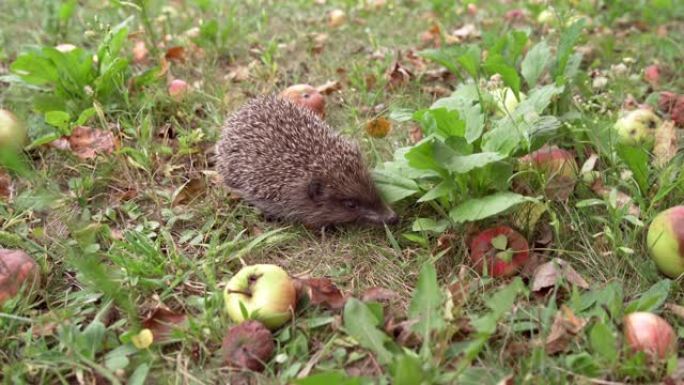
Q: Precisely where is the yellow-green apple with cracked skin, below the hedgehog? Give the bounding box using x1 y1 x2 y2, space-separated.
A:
224 264 297 330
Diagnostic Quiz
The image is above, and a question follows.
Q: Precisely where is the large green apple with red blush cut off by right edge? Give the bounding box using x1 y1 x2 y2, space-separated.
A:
646 206 684 278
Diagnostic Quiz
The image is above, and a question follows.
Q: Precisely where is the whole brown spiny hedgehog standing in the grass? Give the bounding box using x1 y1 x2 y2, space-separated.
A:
216 95 399 228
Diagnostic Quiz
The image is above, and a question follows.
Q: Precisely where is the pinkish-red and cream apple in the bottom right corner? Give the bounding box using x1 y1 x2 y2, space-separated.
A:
623 312 677 360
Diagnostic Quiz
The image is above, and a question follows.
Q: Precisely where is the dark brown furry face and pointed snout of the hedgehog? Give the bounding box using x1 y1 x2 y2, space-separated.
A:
307 179 399 227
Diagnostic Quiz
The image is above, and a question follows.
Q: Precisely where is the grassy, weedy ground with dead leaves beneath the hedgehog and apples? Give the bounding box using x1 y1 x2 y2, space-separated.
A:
0 0 684 384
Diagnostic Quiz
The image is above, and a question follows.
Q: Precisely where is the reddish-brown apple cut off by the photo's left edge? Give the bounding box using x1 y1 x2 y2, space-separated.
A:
0 249 40 306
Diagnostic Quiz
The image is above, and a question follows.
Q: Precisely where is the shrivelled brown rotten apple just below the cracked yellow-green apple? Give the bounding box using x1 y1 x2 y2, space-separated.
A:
222 320 275 372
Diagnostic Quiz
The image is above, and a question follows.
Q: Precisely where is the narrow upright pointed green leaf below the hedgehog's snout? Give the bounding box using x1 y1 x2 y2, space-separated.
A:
408 263 445 351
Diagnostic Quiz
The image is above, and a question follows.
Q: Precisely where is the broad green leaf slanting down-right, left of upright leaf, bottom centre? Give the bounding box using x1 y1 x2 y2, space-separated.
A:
344 298 396 365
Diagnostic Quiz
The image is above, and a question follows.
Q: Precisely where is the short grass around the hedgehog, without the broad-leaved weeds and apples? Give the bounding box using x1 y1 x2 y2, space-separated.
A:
0 0 684 384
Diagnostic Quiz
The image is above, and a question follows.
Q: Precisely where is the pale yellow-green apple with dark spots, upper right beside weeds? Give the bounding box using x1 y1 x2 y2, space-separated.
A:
614 108 662 147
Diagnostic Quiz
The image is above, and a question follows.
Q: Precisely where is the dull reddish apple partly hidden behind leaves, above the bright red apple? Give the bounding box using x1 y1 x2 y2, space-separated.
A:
518 146 579 200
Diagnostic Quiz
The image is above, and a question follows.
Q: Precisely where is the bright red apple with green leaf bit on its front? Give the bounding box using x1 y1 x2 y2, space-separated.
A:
470 226 530 277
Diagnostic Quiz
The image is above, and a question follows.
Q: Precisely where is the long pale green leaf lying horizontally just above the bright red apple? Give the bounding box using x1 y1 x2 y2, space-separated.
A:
449 191 531 223
